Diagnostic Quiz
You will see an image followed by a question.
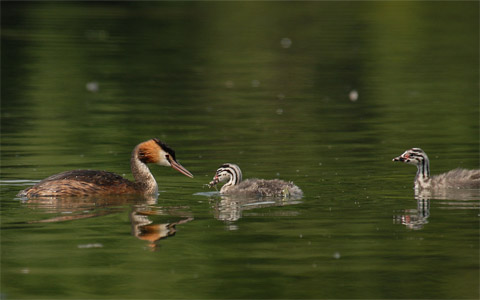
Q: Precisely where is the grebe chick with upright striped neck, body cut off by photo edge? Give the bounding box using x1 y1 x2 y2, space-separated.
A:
393 148 480 190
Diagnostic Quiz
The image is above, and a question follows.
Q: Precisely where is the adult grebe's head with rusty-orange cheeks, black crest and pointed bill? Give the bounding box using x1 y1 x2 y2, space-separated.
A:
138 138 193 178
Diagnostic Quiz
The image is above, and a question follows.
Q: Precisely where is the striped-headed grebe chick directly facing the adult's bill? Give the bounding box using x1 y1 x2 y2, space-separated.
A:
208 163 303 198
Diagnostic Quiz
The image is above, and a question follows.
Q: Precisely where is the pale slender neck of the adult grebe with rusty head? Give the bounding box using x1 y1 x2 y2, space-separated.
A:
130 146 158 195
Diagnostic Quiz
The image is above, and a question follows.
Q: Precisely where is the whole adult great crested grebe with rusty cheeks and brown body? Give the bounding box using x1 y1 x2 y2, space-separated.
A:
17 138 193 198
